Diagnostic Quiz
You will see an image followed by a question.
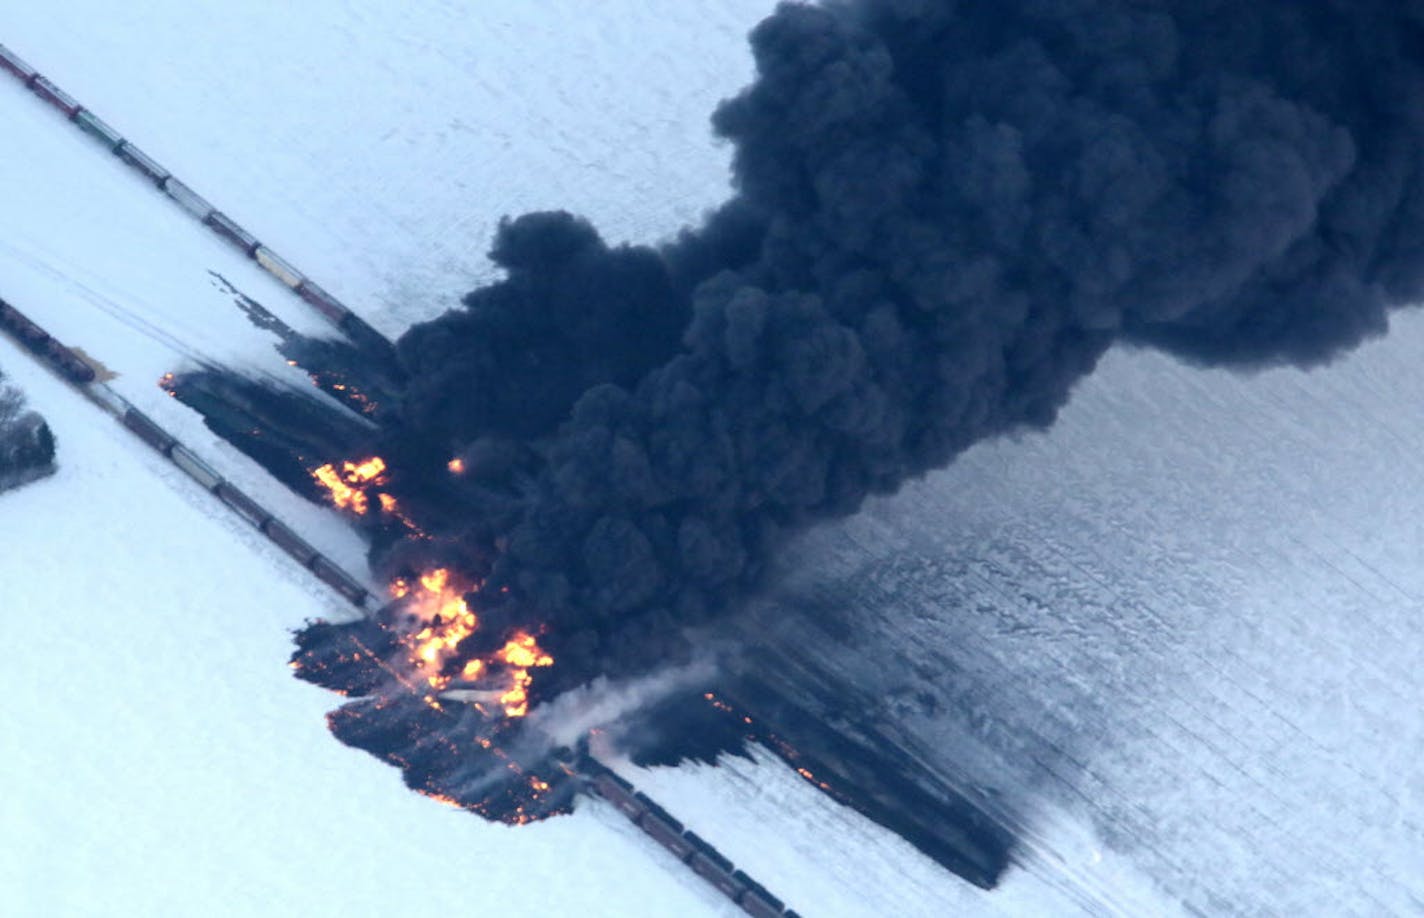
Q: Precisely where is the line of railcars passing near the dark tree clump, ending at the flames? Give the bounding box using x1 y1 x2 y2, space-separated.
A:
0 299 376 608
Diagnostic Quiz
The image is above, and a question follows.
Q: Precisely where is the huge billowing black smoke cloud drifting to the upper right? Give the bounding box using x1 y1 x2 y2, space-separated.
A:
384 0 1424 688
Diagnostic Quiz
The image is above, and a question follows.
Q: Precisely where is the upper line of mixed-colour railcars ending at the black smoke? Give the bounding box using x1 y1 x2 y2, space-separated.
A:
0 44 392 358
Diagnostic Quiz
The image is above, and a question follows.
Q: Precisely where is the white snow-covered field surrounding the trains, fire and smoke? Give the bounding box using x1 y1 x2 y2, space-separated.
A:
0 0 1424 915
